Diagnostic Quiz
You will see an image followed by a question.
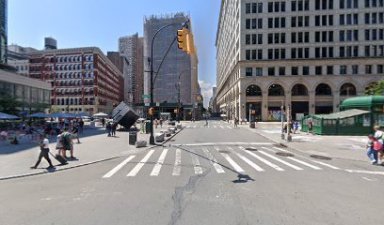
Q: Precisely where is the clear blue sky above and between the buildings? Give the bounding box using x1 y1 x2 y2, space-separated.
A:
8 0 221 106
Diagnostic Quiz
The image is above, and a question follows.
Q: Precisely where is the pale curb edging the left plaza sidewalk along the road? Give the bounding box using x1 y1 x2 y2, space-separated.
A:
0 128 184 181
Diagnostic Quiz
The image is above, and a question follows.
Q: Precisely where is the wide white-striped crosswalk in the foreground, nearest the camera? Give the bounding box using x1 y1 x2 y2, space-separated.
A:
102 145 340 179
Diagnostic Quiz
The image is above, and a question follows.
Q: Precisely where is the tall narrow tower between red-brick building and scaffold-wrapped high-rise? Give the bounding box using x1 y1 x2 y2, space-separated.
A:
119 33 144 105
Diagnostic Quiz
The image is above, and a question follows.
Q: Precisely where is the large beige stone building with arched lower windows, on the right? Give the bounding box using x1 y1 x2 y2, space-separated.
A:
216 0 384 121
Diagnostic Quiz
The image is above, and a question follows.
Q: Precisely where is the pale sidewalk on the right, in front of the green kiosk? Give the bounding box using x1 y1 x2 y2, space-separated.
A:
239 122 368 161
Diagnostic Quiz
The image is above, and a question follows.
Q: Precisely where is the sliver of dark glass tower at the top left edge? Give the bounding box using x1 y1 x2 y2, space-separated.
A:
0 0 7 64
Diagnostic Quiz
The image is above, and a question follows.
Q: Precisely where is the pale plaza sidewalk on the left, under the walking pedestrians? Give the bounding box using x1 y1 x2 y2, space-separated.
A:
0 122 181 180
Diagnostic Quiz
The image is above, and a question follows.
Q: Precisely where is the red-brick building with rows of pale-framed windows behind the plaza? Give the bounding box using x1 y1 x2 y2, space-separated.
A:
29 47 123 115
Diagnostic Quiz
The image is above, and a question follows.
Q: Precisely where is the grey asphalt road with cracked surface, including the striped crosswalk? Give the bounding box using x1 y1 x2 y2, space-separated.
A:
0 121 384 225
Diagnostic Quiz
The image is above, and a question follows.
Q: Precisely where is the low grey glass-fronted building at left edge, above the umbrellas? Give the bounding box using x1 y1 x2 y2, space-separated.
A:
0 69 51 115
